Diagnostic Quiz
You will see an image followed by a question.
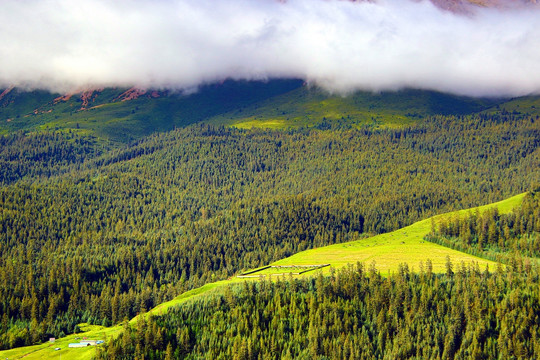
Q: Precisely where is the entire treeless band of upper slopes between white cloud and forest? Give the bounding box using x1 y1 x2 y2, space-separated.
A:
0 80 516 141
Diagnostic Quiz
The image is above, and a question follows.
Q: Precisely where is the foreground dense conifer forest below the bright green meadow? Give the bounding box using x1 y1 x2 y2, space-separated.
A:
97 263 540 360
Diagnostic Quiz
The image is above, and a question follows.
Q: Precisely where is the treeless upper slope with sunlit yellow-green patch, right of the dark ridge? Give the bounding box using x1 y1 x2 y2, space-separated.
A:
206 86 498 129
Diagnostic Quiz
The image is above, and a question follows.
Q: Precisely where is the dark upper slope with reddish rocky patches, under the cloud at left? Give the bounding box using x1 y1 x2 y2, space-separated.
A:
0 80 302 143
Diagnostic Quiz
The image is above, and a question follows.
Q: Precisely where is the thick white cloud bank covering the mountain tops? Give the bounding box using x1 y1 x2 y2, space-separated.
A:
0 0 540 96
